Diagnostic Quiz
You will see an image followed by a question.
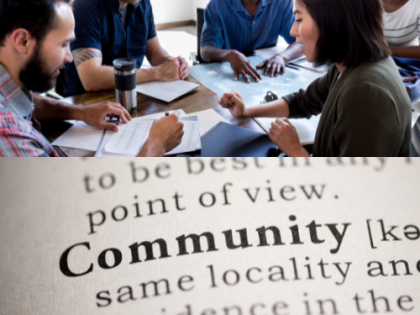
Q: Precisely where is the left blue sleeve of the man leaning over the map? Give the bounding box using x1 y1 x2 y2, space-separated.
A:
201 2 225 49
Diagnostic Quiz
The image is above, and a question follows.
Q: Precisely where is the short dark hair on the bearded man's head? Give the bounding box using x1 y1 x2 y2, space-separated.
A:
0 0 72 46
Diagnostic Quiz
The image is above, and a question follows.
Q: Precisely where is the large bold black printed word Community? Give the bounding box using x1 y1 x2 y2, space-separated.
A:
60 215 351 277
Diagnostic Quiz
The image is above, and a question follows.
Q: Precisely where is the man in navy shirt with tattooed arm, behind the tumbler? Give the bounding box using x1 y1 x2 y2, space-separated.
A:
57 0 189 96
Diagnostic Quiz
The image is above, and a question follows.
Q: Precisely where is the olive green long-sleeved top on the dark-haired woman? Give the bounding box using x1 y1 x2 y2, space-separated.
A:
284 57 411 157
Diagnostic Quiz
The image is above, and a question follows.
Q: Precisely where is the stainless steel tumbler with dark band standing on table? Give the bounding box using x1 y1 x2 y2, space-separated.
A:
113 58 137 113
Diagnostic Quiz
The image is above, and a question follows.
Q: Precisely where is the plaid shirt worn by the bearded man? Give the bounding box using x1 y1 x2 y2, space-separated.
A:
0 65 58 157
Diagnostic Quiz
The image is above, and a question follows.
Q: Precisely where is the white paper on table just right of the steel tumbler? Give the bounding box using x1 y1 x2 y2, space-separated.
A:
137 80 200 103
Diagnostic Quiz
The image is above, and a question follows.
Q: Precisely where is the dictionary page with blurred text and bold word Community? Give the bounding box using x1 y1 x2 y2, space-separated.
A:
0 158 420 315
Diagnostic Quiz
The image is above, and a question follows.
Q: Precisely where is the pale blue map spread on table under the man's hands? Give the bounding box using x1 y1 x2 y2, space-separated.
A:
190 56 323 106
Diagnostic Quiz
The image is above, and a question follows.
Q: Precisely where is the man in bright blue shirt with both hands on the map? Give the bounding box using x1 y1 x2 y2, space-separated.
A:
201 0 302 83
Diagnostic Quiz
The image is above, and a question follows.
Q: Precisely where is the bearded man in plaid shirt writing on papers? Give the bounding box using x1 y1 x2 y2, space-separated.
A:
0 0 183 156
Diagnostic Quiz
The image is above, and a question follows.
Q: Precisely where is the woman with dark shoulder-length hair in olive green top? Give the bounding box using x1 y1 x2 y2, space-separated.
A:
220 0 411 156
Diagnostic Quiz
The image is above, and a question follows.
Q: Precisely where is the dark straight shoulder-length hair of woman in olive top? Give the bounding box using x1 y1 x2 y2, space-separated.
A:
298 0 390 67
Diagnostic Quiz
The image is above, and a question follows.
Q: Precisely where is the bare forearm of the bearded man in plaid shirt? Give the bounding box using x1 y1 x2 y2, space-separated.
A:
32 93 81 121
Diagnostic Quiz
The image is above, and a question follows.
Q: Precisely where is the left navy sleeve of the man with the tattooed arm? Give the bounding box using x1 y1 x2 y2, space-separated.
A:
70 0 104 51
